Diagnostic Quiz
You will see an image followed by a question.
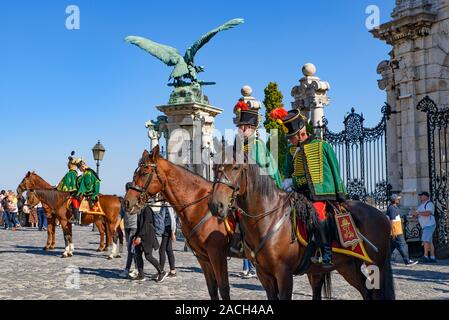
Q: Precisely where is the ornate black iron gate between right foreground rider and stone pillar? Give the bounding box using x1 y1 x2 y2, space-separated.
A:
324 104 391 210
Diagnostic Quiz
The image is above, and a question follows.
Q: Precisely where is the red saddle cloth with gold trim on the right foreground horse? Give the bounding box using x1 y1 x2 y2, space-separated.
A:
295 210 373 263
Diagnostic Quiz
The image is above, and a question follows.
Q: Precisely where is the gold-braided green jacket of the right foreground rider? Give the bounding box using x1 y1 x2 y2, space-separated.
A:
284 138 346 201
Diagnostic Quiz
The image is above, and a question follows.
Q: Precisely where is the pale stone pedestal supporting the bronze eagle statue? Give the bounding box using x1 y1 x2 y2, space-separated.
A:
156 84 223 179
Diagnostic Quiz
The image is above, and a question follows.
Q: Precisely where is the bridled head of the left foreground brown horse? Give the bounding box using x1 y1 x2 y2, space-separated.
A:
124 146 163 214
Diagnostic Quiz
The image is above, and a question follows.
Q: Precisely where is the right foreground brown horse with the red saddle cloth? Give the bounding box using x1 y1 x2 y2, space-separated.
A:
209 163 394 300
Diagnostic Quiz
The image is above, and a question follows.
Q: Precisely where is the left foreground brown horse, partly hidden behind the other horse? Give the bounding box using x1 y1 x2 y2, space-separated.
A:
125 146 230 300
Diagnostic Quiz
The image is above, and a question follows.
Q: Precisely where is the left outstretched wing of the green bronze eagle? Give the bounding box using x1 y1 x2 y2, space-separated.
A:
125 36 189 78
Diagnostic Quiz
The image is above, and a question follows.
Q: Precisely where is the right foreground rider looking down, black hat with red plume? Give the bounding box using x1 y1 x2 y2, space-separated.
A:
270 108 346 267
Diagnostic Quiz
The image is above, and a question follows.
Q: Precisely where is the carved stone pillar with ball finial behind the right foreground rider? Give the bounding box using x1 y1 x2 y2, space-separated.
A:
291 63 330 137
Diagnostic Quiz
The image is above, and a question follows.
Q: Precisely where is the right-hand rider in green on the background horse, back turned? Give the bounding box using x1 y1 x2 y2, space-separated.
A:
76 159 101 211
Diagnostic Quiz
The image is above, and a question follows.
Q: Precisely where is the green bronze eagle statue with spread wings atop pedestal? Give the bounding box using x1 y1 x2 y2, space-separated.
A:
125 19 244 87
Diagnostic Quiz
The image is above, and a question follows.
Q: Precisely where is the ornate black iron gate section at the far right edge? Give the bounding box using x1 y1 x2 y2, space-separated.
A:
418 96 449 246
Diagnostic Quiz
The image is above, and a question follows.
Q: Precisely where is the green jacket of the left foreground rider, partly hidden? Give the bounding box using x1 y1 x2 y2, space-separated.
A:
243 139 282 189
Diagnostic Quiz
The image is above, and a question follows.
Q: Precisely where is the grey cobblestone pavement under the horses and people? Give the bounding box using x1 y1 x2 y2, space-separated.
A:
0 226 449 300
